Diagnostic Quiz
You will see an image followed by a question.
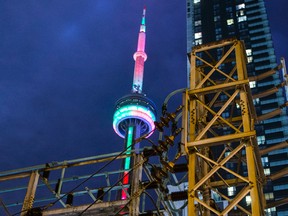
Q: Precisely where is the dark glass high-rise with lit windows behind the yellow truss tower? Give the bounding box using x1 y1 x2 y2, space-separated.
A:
187 0 288 215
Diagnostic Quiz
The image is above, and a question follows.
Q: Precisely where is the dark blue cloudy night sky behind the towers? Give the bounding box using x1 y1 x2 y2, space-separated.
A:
0 0 288 171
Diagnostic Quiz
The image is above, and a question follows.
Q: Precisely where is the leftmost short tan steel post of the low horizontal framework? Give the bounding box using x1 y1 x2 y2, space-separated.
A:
21 171 39 216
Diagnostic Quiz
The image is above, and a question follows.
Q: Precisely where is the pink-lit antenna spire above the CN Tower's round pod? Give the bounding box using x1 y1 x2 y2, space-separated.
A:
132 7 147 93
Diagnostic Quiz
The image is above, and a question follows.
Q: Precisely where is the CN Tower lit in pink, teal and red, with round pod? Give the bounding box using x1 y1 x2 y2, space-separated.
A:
113 7 156 199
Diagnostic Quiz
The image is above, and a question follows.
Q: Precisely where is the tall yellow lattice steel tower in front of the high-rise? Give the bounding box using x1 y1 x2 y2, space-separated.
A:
184 39 265 216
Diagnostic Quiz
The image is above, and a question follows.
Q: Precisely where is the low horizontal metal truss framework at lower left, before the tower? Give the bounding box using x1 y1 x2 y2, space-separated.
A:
0 148 169 216
